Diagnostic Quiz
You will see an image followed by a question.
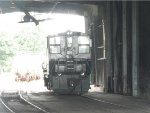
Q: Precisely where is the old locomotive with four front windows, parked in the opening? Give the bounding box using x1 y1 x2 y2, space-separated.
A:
43 31 91 94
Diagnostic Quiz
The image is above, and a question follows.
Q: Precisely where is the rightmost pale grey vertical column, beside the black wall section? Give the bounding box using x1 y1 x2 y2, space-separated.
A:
132 2 139 96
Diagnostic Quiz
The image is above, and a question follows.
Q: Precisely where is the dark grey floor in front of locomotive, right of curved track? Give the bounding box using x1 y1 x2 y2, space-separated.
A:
19 92 150 113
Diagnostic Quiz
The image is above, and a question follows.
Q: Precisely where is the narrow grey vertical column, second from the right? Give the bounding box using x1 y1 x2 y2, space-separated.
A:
122 2 128 94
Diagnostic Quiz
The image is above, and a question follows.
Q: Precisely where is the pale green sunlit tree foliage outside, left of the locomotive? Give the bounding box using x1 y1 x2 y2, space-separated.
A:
0 25 46 71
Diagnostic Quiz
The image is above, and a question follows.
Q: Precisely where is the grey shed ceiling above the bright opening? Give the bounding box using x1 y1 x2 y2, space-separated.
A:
0 0 97 13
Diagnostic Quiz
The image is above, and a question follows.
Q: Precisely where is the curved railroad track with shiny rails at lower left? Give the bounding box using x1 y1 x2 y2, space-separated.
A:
0 91 50 113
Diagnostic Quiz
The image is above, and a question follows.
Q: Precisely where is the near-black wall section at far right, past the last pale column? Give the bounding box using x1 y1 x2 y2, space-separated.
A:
139 2 150 97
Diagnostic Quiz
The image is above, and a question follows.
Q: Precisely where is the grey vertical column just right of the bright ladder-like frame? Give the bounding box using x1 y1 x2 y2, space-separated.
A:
104 2 113 92
